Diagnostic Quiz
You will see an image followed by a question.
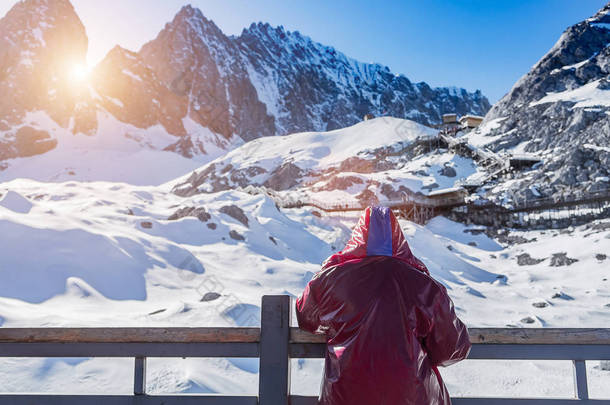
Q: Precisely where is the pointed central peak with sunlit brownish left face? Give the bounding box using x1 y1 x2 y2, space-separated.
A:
140 6 275 140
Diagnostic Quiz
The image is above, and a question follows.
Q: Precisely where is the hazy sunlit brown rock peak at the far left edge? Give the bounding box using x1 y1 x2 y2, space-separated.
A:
0 0 95 160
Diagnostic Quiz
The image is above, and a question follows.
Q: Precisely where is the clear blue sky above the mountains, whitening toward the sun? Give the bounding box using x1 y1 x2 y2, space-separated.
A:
0 0 606 103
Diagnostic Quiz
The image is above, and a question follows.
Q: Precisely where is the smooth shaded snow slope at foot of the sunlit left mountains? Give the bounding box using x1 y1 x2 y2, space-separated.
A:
0 111 243 185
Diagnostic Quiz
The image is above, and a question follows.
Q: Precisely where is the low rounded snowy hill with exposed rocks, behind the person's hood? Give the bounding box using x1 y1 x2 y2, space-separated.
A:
173 117 480 205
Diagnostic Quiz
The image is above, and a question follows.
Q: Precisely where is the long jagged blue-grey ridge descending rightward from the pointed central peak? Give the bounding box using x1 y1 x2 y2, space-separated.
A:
236 23 490 134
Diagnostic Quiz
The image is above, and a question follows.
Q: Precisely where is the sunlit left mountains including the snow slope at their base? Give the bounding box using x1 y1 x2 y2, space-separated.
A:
0 0 238 184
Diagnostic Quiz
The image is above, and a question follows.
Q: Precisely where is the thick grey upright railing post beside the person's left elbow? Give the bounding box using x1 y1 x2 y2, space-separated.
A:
258 295 290 405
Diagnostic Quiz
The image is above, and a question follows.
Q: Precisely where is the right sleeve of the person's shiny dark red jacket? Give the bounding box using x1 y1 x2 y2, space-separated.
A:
423 284 470 367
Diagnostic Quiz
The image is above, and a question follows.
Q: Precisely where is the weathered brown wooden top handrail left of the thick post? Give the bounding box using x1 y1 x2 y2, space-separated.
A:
0 327 260 343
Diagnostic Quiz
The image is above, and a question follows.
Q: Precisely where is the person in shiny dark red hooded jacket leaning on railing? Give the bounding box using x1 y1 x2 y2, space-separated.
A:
296 207 470 405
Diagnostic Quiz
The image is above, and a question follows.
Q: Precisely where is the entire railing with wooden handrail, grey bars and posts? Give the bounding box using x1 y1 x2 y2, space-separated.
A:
0 295 610 405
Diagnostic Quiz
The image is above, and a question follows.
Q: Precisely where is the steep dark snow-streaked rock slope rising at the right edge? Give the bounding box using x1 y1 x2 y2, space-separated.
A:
472 5 610 199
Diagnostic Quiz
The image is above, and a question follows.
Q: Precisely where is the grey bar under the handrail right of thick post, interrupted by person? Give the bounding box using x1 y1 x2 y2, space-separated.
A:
289 343 610 360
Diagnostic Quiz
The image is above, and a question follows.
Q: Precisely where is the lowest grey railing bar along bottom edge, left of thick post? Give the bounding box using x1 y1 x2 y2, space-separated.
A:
0 394 258 405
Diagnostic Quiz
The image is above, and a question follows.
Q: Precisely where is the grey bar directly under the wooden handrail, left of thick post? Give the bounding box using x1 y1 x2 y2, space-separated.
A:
0 343 259 357
